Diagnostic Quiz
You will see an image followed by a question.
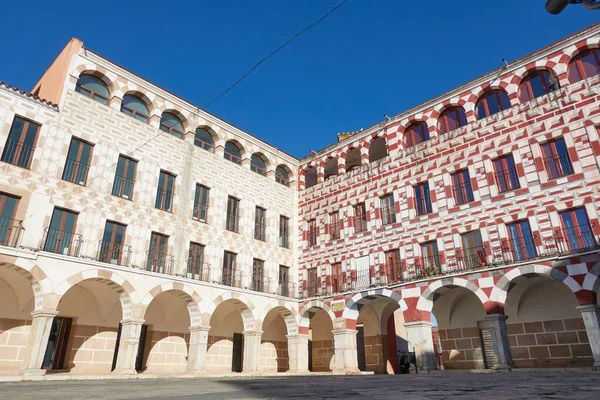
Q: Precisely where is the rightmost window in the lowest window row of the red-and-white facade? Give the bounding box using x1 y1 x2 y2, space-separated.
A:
556 208 596 251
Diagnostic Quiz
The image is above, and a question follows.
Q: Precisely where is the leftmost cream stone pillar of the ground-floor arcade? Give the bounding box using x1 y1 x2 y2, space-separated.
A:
21 310 58 375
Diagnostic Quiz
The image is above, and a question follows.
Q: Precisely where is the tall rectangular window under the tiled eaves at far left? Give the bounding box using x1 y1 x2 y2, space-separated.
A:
2 117 40 169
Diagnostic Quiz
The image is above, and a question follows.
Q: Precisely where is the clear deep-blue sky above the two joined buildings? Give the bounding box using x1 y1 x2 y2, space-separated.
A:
0 0 600 157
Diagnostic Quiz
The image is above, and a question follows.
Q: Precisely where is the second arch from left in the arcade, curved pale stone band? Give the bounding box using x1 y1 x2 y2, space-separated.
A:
54 269 140 319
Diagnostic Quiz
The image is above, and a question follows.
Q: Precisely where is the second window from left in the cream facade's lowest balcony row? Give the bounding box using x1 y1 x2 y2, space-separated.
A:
44 208 81 256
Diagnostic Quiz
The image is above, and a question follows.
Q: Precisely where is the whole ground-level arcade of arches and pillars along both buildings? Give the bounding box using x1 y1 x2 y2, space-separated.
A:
0 249 600 375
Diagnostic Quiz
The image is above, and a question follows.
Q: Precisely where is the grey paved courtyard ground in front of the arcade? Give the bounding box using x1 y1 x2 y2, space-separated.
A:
0 371 600 400
